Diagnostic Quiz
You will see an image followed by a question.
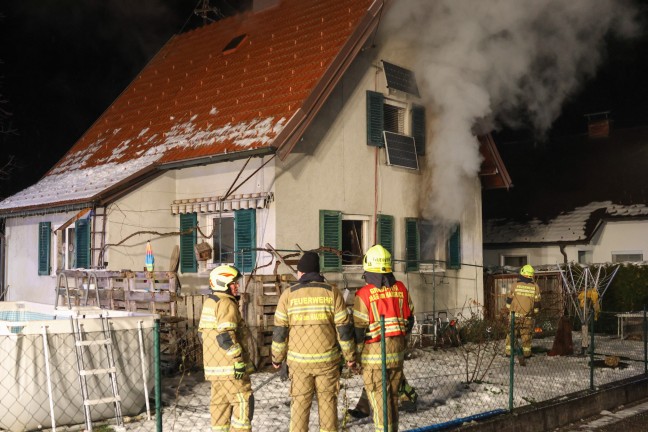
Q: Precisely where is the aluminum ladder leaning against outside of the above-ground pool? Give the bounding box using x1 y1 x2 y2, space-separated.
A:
70 315 125 432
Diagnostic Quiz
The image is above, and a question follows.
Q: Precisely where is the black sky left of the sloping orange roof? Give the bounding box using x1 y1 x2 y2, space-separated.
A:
0 0 249 197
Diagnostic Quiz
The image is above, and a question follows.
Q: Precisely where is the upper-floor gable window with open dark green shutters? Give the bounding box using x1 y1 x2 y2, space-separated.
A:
367 91 425 155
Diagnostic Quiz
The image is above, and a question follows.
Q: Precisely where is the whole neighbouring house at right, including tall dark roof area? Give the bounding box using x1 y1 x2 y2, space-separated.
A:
484 122 648 268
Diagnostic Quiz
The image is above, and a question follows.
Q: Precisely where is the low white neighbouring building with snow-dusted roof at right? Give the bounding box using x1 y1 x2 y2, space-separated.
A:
484 201 648 268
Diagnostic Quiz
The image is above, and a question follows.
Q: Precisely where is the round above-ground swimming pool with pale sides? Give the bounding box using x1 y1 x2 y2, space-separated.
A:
0 302 158 432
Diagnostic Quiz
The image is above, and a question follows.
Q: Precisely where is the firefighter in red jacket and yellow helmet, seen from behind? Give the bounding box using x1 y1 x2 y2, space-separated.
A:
353 245 414 432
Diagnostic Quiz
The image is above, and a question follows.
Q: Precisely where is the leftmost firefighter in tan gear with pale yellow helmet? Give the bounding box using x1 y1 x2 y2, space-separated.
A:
198 265 254 432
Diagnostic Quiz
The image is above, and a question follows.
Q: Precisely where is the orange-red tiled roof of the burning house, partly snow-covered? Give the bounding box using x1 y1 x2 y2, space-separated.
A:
0 0 382 216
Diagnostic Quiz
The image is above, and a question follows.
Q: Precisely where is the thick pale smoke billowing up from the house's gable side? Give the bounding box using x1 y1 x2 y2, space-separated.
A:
379 0 638 224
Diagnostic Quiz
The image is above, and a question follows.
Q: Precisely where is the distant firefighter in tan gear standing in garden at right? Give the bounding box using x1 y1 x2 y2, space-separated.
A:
506 264 540 358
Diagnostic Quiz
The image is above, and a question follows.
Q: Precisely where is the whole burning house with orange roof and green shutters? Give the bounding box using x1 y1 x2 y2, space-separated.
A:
0 0 510 312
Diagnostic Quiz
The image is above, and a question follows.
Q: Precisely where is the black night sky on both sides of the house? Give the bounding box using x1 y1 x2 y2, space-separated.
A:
0 0 648 216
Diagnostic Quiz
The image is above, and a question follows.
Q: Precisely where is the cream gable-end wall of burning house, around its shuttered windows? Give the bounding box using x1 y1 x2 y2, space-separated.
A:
275 48 483 313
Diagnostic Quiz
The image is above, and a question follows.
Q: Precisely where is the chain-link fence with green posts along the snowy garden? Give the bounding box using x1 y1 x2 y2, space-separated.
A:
0 311 647 432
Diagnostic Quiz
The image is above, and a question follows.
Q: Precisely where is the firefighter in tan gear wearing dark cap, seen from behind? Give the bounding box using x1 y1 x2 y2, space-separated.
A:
272 252 355 432
